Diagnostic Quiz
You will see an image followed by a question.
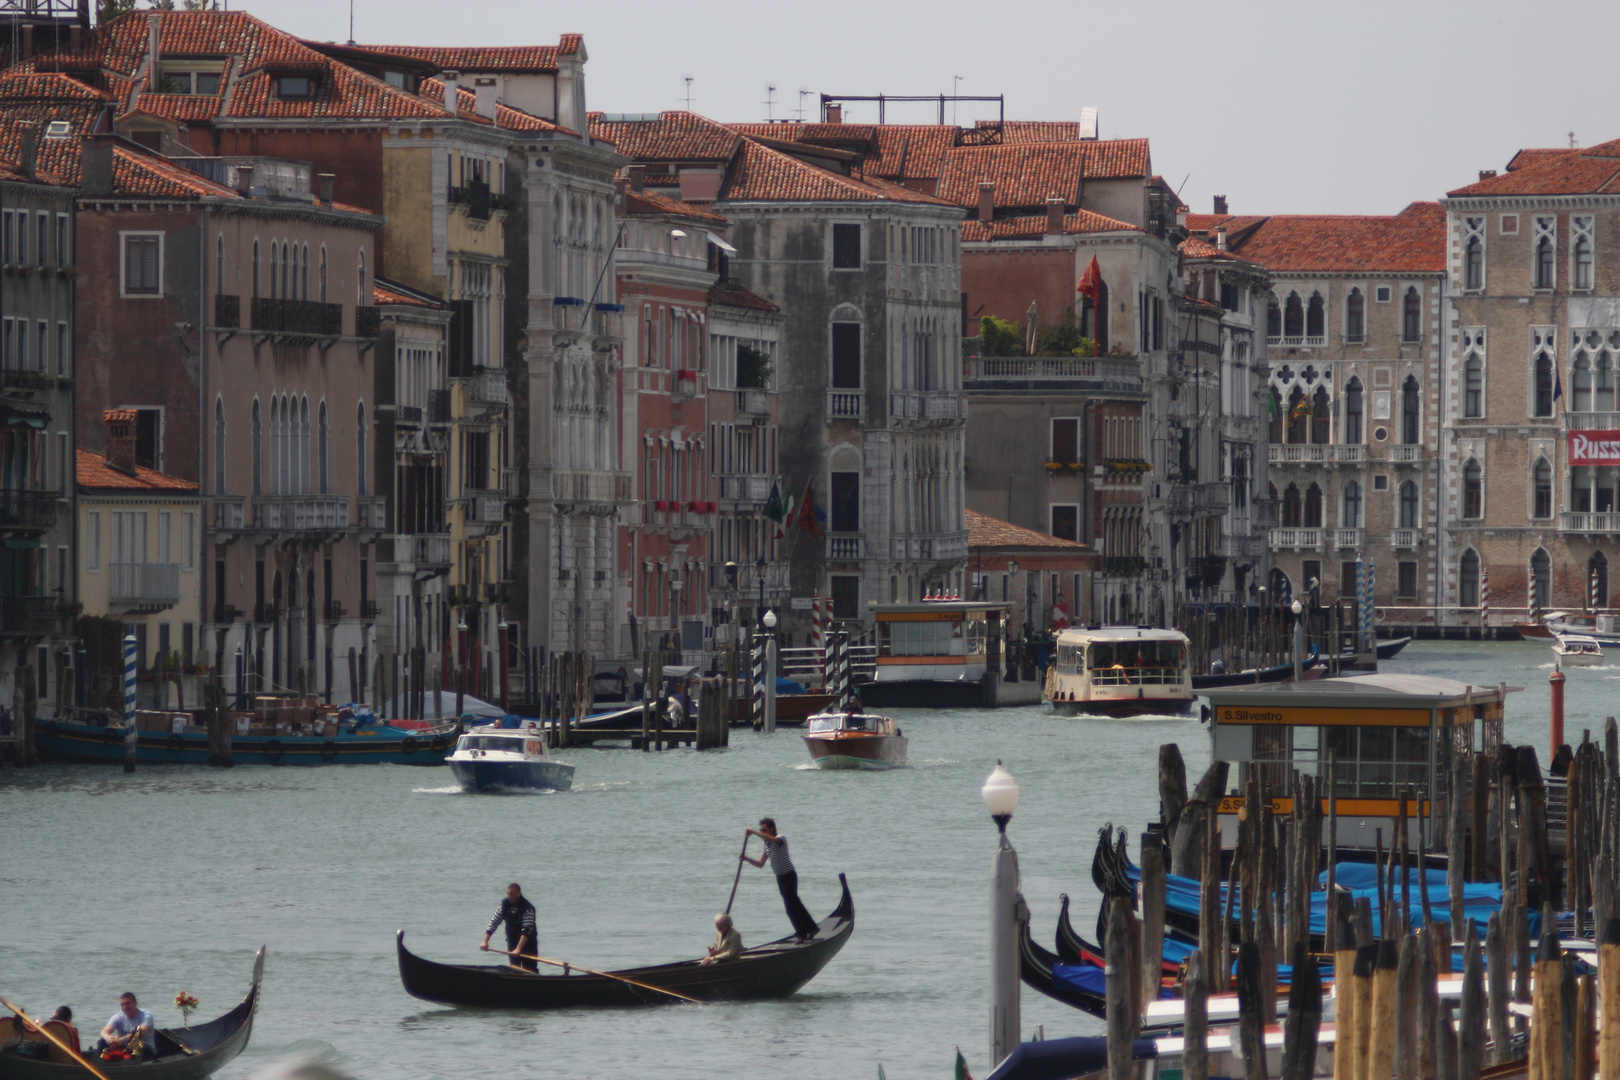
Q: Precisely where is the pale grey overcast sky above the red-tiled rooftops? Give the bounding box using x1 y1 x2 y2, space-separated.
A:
259 0 1620 214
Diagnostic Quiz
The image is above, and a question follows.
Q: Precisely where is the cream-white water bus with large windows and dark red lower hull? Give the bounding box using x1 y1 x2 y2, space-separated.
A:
1045 627 1194 716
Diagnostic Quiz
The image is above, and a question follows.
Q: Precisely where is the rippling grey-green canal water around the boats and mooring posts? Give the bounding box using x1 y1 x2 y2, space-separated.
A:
0 641 1620 1080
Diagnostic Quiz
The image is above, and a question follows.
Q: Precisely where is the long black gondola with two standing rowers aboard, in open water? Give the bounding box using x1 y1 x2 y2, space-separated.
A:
395 874 855 1009
